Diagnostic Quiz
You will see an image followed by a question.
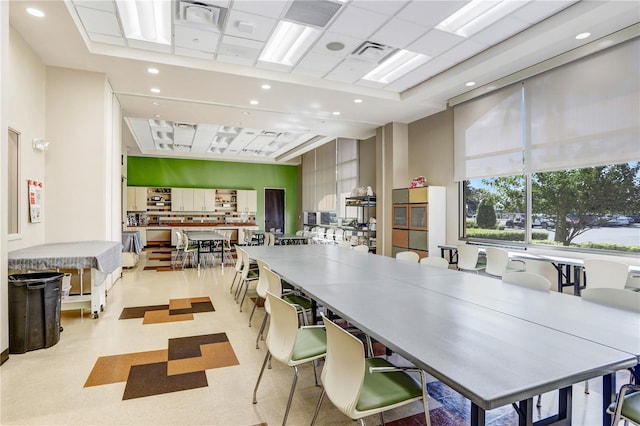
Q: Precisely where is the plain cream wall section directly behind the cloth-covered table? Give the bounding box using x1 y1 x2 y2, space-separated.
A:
44 67 112 243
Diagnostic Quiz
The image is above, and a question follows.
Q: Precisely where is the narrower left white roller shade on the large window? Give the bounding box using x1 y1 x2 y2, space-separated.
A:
453 84 524 181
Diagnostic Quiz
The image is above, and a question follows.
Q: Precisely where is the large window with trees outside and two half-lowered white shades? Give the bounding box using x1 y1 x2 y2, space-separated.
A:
454 39 640 252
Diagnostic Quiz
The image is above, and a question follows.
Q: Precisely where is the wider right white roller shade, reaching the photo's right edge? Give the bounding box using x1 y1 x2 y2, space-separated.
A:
525 39 640 172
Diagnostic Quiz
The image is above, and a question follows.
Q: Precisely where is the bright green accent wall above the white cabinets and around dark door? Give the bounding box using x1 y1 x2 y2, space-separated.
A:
127 157 298 233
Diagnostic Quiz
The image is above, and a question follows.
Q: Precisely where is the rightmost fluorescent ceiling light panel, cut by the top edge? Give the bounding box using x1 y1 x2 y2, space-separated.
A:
436 0 530 37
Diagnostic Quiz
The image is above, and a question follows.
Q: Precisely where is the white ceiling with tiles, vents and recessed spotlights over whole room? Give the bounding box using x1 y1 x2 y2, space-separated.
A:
10 0 640 162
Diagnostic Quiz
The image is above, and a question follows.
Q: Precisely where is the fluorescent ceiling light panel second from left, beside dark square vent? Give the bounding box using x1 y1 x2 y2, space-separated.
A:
259 21 322 66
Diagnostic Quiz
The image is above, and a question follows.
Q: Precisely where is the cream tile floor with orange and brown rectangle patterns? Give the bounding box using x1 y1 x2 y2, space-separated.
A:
0 253 626 426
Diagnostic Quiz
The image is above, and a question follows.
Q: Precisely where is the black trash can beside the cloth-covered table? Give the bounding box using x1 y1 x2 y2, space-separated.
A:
9 272 64 354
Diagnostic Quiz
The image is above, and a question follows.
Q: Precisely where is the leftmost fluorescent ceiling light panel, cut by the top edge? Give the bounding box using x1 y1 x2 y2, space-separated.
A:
116 0 171 45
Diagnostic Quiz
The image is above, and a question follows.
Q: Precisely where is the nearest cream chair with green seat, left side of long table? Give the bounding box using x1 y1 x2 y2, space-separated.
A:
311 312 431 426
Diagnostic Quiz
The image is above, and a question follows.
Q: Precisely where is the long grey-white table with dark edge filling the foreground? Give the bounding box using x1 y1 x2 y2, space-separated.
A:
246 245 640 426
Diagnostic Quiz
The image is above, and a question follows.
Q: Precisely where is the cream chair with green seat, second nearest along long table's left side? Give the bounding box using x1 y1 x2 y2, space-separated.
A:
253 291 327 425
